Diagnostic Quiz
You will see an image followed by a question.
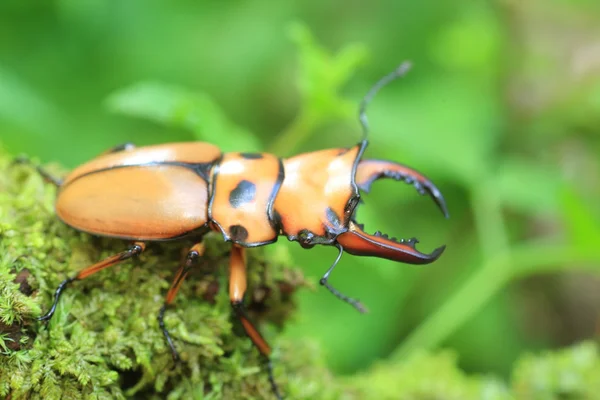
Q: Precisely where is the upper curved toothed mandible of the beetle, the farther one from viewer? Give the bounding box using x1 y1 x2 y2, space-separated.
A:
355 160 449 218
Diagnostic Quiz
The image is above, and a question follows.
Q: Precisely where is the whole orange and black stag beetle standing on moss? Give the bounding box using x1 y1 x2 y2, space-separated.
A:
27 63 448 398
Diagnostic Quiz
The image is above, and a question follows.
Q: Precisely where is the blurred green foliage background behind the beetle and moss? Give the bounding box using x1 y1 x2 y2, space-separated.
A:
0 0 600 382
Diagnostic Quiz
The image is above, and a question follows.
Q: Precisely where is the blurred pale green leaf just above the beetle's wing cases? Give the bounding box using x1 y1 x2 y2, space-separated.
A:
107 82 261 151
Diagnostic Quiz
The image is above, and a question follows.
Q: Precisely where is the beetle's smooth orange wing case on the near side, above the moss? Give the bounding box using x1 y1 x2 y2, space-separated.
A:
56 164 208 240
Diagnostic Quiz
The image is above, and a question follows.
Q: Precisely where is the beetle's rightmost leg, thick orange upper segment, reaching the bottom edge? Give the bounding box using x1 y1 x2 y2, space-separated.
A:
229 245 282 400
